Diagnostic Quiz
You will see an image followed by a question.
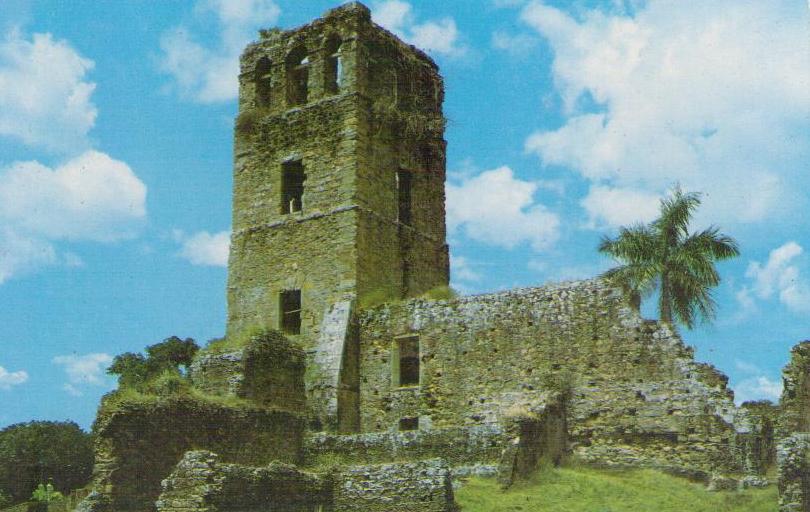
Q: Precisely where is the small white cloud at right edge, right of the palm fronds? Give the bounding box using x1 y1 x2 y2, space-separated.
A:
737 241 810 313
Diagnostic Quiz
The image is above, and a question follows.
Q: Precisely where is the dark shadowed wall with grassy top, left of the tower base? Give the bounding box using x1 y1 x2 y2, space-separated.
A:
80 397 304 512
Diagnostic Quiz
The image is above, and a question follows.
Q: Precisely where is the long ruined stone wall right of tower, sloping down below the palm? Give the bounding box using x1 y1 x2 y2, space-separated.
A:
360 281 742 477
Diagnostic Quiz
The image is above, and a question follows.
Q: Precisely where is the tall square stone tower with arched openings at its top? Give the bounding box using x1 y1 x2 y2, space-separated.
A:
228 2 449 350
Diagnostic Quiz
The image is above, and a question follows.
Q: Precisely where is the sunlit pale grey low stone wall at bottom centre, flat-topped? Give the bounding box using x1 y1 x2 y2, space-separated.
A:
334 459 458 512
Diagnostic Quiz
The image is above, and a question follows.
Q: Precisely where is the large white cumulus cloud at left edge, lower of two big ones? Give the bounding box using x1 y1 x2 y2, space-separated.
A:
0 151 146 283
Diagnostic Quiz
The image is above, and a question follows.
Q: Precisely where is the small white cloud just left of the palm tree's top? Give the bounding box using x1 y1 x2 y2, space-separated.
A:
580 186 660 227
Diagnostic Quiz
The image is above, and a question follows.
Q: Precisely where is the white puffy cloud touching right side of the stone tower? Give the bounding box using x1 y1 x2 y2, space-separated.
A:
446 166 560 251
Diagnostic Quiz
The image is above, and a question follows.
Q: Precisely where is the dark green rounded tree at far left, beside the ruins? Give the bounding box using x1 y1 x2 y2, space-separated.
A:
0 421 93 503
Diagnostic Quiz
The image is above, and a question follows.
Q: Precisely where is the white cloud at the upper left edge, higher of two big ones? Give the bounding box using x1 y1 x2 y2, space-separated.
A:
0 30 97 151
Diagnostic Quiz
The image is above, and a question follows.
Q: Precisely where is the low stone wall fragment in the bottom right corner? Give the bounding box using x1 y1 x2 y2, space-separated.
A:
777 433 810 512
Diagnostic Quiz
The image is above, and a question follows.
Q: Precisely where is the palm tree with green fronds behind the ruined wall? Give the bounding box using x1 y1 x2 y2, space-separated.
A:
599 186 740 329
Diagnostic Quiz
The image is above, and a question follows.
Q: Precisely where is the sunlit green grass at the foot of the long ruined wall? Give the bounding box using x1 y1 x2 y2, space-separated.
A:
456 467 777 512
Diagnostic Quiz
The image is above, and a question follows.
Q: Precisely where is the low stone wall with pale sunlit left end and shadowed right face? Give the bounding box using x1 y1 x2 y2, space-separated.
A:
156 451 332 512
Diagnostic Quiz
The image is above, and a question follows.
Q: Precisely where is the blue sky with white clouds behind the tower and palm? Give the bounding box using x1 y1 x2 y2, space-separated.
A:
0 0 810 427
